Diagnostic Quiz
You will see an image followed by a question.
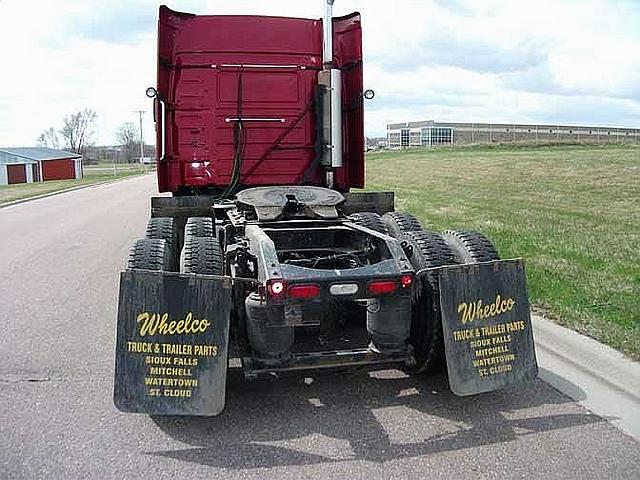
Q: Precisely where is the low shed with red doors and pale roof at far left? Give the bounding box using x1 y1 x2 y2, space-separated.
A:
0 147 82 185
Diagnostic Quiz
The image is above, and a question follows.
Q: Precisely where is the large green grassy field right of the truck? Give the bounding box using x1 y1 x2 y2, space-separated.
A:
367 146 640 359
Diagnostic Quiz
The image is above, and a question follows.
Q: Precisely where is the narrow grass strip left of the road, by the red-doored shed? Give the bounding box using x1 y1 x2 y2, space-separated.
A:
0 164 150 205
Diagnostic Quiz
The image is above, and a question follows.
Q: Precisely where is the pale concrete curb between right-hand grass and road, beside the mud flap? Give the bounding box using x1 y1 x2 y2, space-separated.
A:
532 315 640 441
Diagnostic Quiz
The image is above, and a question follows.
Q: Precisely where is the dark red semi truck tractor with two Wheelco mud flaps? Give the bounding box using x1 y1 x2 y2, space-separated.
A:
114 0 537 415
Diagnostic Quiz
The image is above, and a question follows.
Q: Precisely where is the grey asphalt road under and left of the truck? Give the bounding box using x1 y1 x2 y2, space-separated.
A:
0 176 640 479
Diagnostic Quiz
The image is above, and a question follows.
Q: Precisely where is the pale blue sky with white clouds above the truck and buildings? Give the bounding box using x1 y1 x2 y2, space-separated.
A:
0 0 640 146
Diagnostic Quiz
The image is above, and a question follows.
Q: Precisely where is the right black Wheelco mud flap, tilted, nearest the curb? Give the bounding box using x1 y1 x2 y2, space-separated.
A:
438 259 538 396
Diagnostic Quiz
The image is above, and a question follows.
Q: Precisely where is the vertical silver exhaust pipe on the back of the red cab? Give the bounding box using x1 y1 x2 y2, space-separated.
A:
322 0 342 188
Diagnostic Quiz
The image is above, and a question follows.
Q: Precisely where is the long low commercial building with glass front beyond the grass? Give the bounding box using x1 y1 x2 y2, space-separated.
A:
387 120 640 148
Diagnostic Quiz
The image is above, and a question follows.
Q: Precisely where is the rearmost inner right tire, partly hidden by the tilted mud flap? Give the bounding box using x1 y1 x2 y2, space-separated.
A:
403 231 457 373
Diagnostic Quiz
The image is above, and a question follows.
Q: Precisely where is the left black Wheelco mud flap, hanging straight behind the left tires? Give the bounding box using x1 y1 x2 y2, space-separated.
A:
113 270 231 415
